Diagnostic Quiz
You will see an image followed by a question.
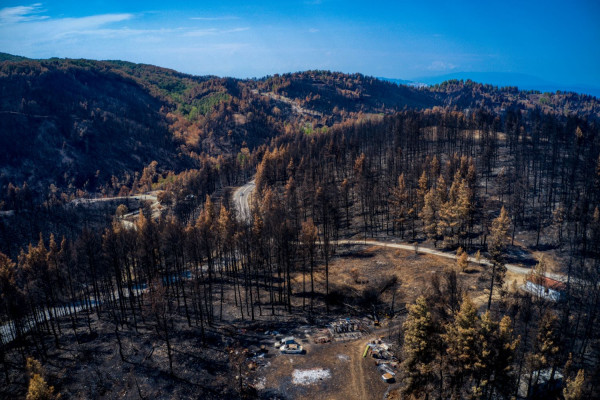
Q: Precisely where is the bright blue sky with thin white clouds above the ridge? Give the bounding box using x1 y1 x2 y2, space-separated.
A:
0 0 600 86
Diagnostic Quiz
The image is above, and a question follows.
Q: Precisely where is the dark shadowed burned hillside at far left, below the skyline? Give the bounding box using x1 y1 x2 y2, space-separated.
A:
0 61 176 195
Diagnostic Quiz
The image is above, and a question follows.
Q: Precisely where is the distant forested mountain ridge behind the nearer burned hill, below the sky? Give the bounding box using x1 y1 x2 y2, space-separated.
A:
0 53 600 199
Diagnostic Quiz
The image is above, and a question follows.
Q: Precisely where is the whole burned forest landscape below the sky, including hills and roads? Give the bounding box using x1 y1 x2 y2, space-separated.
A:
0 59 600 400
